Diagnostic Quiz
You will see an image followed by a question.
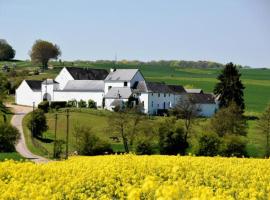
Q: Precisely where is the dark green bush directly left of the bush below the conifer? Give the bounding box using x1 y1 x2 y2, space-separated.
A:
195 133 221 156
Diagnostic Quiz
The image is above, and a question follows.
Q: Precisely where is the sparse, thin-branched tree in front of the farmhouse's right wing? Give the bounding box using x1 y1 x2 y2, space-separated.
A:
170 95 200 142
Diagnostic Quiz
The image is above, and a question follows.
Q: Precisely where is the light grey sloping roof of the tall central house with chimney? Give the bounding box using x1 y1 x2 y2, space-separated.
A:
105 69 138 81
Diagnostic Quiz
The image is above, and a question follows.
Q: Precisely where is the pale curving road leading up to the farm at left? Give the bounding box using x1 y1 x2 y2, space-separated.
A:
7 105 48 163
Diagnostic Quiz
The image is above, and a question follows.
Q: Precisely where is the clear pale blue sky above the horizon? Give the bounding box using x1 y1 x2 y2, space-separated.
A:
0 0 270 68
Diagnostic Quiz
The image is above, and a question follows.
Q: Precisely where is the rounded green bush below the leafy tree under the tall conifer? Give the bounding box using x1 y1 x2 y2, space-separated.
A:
220 135 247 157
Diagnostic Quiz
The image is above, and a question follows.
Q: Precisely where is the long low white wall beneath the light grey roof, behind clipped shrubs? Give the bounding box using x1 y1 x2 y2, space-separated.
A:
54 91 104 107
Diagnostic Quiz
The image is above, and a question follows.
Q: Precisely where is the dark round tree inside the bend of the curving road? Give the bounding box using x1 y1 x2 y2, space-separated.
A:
27 109 48 138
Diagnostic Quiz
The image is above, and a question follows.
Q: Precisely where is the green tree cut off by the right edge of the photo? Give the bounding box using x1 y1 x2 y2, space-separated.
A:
258 105 270 157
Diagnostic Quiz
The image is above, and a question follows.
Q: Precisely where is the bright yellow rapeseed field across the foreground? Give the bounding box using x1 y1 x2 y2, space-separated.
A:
0 154 270 200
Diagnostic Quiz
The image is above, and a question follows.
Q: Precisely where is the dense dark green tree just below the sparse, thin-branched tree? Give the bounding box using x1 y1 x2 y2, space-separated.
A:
158 118 188 155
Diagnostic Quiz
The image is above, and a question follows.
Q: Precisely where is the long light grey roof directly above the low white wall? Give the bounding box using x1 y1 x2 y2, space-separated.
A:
63 80 104 91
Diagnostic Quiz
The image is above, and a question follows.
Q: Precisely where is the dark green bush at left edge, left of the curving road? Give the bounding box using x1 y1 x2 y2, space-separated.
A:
0 124 20 152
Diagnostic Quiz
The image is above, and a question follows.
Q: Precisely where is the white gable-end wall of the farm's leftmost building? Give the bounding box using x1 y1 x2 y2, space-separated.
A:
15 81 42 107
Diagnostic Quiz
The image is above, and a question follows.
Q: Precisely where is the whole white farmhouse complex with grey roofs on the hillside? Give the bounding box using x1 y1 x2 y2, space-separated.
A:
16 67 218 116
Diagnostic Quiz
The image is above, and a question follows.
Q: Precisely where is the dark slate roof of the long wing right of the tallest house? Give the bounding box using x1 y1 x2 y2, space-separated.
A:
134 81 186 94
